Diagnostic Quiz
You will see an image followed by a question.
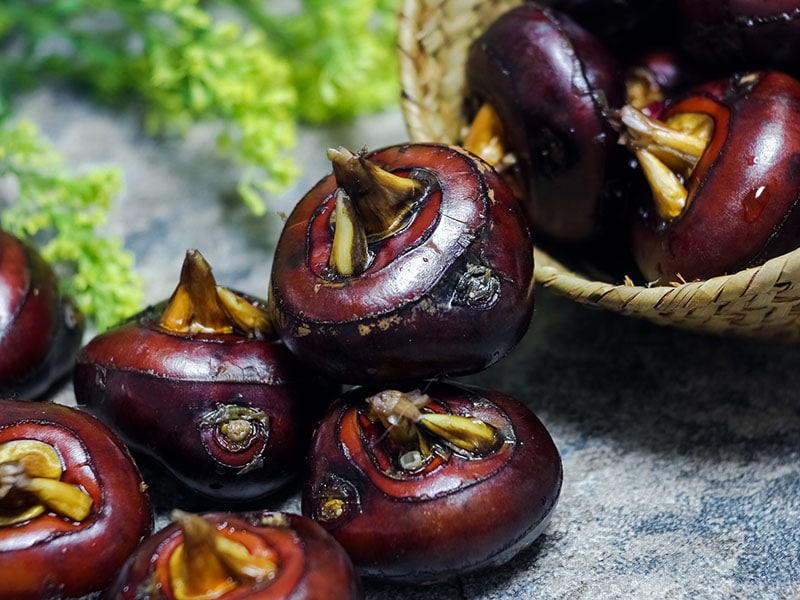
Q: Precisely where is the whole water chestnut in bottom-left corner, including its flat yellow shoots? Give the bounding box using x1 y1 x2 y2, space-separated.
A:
0 399 153 600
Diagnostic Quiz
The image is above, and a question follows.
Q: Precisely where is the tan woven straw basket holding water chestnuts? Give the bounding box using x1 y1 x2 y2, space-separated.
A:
398 0 800 342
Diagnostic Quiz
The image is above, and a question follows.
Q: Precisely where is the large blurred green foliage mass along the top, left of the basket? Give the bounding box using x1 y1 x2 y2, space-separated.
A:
0 0 399 214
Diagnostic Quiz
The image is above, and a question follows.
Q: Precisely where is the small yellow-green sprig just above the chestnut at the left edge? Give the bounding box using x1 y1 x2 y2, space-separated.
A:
0 121 143 330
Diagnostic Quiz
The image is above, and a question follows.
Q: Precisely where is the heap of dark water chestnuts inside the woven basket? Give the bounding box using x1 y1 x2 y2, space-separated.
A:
460 0 800 285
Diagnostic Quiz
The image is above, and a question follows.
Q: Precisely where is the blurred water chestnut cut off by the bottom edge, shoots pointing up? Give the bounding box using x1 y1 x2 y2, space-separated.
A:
103 511 363 600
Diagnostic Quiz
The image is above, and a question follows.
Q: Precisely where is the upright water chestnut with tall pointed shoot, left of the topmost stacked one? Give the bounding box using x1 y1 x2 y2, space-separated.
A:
74 251 339 502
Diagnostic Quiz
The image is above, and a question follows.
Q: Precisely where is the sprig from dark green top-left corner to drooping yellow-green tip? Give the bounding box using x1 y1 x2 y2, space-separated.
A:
0 0 304 214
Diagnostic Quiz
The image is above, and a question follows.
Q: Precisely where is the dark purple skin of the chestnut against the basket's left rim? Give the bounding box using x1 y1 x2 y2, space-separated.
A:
465 4 625 242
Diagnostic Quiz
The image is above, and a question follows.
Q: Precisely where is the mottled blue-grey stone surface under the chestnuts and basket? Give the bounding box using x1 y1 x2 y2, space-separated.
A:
18 89 800 600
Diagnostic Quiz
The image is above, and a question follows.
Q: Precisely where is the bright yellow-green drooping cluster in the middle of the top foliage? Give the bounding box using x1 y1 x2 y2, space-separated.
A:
139 0 297 214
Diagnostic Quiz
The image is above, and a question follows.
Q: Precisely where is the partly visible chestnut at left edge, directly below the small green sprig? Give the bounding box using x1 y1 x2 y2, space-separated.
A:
0 231 84 399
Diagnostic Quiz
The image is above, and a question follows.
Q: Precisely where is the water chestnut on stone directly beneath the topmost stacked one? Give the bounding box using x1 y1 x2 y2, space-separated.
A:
302 381 562 583
